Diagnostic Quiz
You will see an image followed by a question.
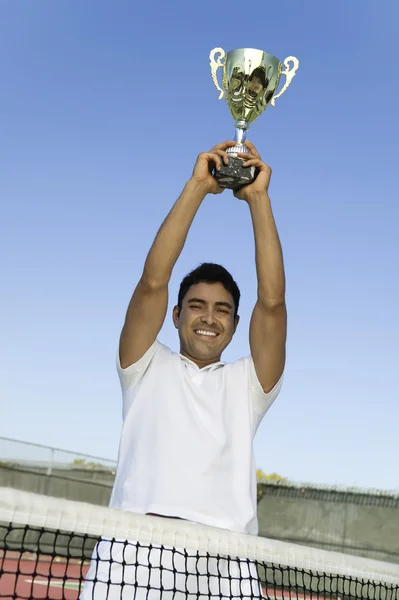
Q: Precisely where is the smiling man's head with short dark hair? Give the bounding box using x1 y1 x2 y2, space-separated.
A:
173 263 240 367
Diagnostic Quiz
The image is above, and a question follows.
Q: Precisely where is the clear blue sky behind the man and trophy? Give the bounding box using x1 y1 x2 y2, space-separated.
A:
0 0 399 488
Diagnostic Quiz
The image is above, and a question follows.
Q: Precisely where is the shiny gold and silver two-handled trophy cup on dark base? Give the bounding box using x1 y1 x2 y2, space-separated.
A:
209 48 299 190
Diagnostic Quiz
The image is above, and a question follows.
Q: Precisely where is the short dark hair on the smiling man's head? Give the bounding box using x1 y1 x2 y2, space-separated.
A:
177 263 241 317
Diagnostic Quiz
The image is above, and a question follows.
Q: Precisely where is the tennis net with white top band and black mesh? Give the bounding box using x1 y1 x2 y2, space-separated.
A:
0 488 399 600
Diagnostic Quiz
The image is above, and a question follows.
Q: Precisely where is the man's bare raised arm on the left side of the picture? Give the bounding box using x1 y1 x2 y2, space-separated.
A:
119 142 232 368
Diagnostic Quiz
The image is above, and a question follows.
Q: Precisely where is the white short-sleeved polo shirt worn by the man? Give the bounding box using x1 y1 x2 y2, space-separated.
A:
110 341 282 535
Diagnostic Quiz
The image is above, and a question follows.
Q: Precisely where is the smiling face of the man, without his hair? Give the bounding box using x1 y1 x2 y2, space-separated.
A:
173 283 238 367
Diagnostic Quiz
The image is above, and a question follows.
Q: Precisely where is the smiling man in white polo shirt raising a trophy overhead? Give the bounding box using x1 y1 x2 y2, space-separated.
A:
82 142 287 598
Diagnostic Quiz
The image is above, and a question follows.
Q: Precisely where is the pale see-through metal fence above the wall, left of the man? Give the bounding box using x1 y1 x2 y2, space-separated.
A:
0 437 116 479
